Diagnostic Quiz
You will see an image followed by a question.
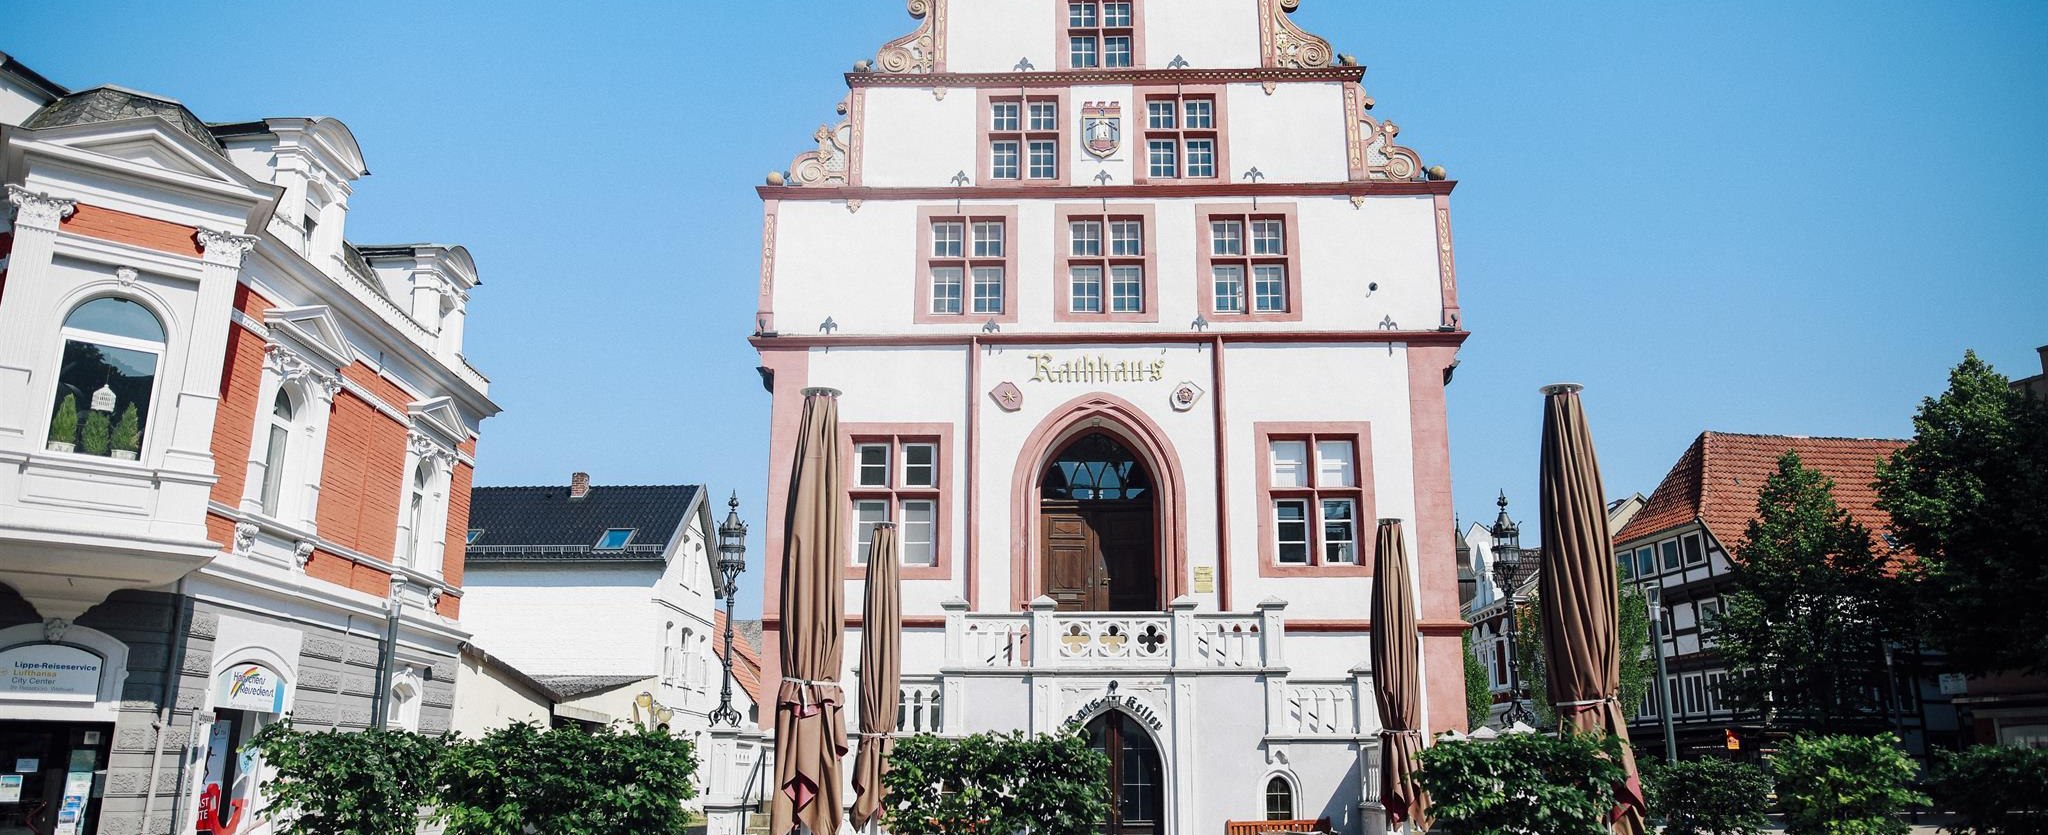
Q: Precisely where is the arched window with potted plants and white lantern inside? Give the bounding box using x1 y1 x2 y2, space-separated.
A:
47 297 166 460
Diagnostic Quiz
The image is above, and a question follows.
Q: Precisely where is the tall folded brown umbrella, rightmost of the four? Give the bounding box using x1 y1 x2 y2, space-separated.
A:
1536 385 1645 833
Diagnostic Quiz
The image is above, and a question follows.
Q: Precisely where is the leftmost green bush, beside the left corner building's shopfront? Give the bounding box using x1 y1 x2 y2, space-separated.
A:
250 718 442 835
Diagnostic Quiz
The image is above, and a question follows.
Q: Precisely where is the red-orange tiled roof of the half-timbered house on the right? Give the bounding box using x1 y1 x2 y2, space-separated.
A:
1614 432 1907 551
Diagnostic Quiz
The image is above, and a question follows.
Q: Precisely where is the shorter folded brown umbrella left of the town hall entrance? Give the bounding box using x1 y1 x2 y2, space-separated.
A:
854 522 903 829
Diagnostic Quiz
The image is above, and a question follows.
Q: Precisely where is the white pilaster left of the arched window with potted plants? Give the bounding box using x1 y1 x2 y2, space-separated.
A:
0 184 78 450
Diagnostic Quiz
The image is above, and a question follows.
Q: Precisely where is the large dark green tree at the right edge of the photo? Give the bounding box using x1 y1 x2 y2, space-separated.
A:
1878 352 2048 673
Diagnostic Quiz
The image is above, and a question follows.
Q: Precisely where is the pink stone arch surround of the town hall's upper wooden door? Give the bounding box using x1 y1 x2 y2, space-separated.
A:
1010 393 1188 612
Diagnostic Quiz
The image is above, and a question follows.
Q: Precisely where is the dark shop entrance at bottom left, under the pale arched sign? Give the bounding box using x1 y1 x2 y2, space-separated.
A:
0 720 113 835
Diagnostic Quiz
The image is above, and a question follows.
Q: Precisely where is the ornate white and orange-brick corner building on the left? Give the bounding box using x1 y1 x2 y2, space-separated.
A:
0 55 498 835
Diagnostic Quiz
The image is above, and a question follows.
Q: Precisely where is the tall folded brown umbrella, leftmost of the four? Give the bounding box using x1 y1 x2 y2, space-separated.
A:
768 389 846 835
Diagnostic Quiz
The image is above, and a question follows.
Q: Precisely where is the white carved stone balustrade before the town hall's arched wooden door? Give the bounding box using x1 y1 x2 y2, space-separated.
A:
944 598 1286 669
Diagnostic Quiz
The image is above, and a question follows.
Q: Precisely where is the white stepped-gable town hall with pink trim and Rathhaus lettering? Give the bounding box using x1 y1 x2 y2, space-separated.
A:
752 0 1466 833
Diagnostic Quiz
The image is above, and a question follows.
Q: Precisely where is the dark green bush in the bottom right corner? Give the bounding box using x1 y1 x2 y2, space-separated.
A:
1927 745 2048 835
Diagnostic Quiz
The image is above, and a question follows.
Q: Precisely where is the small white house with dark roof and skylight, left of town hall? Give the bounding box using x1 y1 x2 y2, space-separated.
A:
463 473 754 743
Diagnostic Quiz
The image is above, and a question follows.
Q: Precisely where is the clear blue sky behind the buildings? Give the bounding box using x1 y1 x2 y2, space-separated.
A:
12 0 2048 610
